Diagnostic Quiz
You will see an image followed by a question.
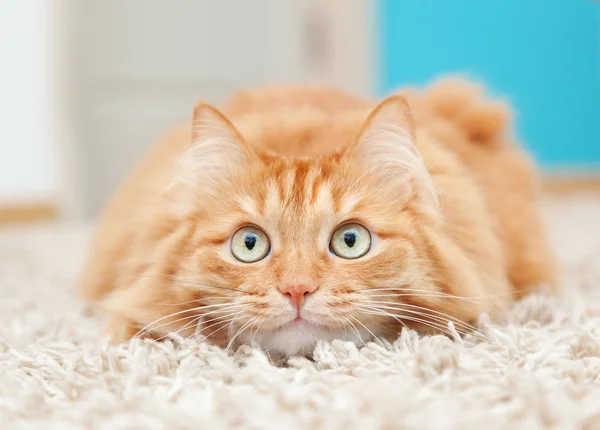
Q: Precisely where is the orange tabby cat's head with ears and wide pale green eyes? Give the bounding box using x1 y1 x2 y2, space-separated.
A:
113 96 488 355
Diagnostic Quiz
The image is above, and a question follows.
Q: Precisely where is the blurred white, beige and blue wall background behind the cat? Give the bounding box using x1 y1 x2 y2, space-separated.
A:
0 0 600 223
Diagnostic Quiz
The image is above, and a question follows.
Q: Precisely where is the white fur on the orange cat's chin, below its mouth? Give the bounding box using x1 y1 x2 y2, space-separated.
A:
241 323 371 357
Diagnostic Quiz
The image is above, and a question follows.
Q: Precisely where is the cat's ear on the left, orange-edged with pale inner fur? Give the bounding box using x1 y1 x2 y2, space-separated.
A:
166 103 253 215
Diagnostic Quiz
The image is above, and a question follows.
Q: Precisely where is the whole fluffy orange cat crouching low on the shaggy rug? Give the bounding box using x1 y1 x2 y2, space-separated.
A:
83 81 554 355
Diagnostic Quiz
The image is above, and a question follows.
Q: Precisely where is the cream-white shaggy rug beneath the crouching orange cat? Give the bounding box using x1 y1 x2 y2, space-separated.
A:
0 196 600 430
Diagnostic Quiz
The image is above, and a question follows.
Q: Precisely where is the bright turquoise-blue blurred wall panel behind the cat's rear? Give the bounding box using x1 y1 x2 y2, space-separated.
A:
375 0 600 170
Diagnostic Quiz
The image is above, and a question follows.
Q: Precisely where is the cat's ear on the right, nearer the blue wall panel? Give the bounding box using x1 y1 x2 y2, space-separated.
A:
351 95 438 212
